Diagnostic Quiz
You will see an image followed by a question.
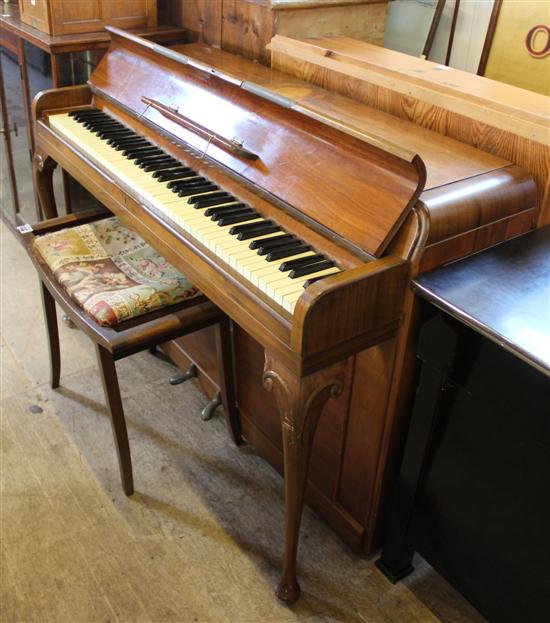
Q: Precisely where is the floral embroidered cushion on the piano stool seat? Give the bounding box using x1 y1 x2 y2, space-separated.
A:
34 217 200 327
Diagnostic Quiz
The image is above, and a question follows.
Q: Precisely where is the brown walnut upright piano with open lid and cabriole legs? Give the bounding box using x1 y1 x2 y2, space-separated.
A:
34 31 535 603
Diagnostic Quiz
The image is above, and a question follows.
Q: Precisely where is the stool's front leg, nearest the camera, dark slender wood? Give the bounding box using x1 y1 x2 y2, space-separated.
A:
96 344 134 495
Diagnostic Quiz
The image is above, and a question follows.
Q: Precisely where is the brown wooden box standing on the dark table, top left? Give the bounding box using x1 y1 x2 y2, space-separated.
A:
19 0 157 35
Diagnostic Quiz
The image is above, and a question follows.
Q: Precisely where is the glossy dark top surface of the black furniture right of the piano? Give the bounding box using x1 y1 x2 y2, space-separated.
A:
413 226 550 376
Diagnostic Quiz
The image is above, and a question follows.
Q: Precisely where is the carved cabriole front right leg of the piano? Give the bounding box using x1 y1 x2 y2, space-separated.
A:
263 353 344 605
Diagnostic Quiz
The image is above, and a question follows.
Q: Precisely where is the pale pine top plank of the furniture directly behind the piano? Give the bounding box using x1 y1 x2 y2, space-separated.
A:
269 35 550 145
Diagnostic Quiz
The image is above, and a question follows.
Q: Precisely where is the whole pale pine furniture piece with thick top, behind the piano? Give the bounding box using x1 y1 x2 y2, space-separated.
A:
269 36 550 227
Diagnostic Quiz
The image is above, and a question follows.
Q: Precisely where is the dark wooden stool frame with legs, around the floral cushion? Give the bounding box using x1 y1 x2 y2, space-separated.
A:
18 209 242 495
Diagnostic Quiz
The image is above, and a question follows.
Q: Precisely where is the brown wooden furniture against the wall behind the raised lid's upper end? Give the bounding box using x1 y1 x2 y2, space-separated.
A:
170 0 388 65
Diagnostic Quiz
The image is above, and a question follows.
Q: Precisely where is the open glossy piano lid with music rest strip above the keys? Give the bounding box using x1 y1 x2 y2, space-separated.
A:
89 28 425 256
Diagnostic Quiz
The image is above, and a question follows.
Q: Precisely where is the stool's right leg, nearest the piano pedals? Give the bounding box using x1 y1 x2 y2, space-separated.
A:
216 316 243 446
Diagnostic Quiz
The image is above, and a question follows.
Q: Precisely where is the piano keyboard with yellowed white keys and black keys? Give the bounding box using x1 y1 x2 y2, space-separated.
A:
49 109 340 313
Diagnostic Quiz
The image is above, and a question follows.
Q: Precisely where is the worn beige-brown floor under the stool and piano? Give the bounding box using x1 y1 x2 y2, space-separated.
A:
0 219 490 623
